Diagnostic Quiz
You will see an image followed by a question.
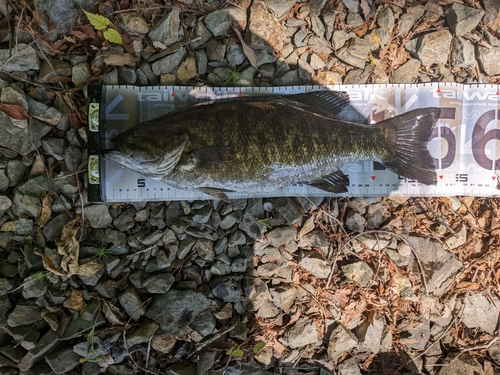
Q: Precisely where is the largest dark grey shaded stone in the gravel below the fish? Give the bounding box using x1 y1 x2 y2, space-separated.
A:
145 289 210 335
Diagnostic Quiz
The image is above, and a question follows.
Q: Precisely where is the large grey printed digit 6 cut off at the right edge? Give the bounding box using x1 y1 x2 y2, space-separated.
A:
471 109 500 170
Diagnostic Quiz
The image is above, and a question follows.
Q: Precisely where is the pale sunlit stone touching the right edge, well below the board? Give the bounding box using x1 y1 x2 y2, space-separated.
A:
462 294 499 335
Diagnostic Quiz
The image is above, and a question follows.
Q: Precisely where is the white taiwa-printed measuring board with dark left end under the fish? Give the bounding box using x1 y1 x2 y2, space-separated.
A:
88 83 500 202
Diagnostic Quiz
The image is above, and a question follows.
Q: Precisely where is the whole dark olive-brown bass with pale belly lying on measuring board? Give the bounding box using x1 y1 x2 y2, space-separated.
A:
104 91 440 201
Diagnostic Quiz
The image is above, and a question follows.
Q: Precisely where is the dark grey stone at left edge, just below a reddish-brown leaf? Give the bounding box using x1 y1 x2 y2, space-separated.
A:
0 116 51 155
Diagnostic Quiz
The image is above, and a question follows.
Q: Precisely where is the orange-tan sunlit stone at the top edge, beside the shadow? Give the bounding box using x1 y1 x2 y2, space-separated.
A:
248 1 285 52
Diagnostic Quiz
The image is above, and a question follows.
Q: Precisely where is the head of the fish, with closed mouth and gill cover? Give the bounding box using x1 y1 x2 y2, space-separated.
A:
106 124 188 179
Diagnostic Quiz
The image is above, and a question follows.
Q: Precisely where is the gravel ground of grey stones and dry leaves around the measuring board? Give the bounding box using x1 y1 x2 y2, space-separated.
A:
0 0 500 375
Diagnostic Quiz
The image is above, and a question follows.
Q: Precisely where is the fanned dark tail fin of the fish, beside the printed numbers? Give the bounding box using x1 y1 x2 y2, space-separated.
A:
378 108 440 185
